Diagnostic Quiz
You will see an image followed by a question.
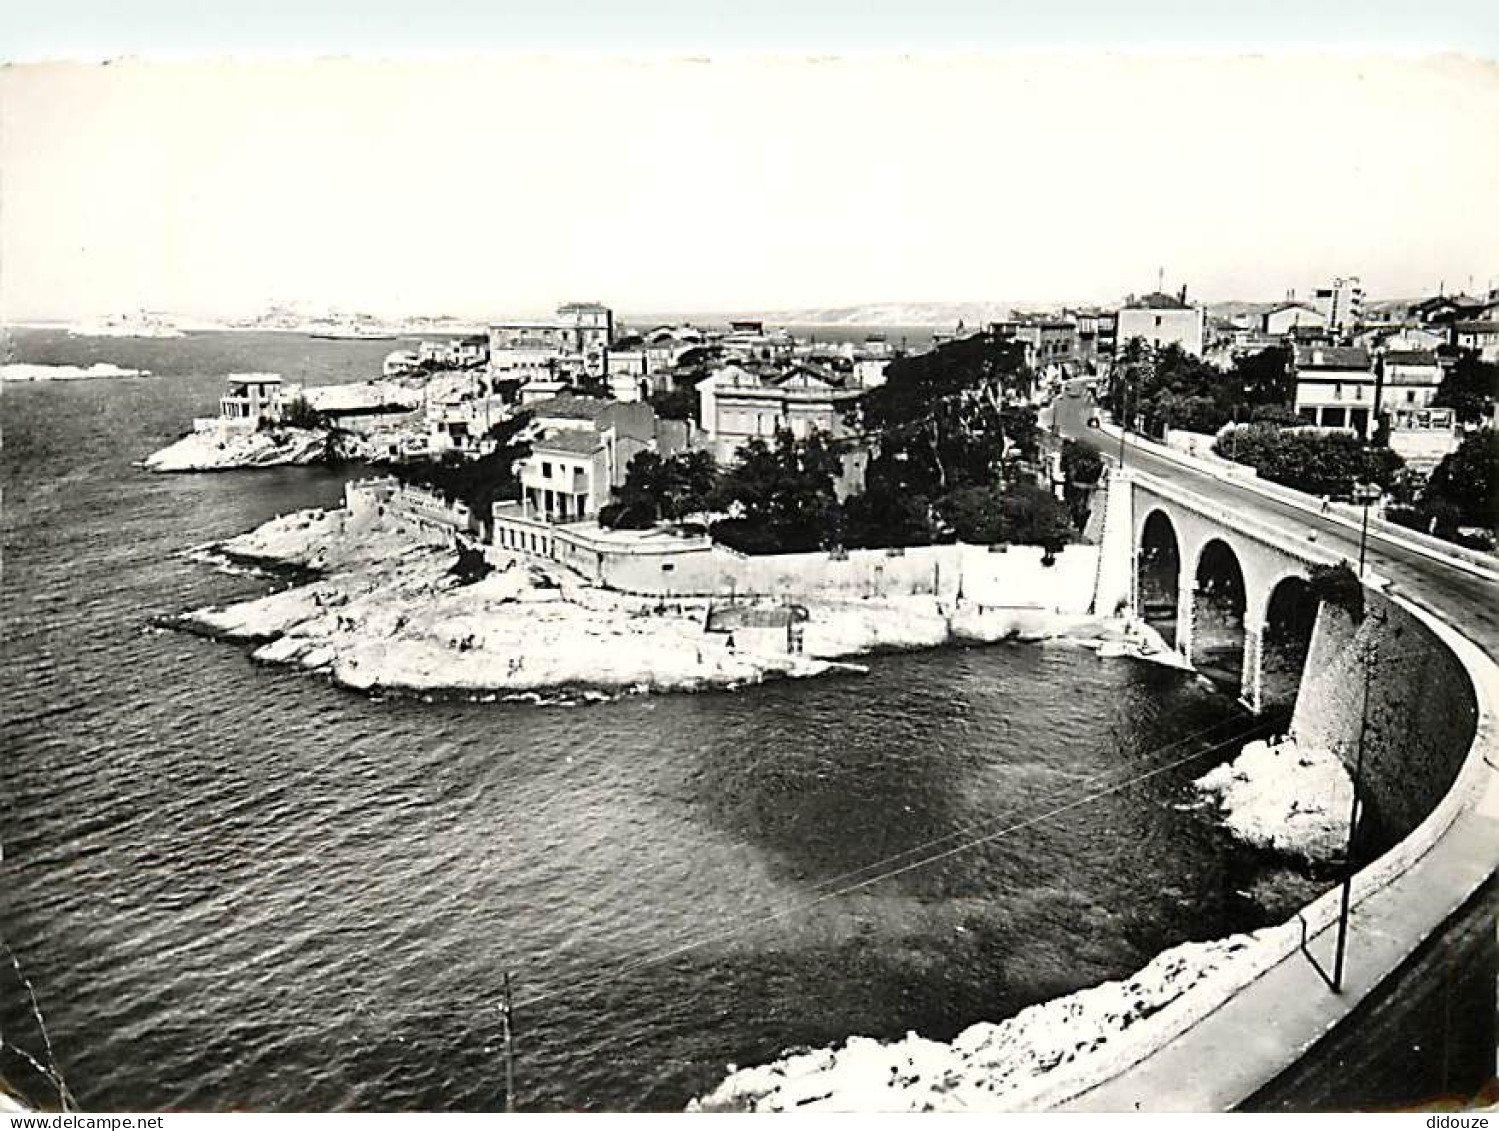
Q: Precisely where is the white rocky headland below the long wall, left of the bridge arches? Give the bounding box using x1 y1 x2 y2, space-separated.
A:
169 509 1181 697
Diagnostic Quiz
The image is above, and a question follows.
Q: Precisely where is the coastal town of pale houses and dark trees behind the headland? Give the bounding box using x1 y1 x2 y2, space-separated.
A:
155 277 1499 566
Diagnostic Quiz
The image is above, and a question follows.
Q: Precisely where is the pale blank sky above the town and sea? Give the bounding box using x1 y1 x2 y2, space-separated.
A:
0 6 1499 321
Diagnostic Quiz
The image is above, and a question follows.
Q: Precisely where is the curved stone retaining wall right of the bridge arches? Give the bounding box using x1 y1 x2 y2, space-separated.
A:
1291 592 1478 837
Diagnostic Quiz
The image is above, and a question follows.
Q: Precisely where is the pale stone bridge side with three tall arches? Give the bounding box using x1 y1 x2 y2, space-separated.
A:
1111 475 1331 713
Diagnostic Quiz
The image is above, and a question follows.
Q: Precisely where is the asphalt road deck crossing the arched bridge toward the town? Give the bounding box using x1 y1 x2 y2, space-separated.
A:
1054 380 1499 661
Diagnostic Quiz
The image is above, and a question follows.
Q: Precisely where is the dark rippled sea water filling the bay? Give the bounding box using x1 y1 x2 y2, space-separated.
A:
0 333 1283 1110
